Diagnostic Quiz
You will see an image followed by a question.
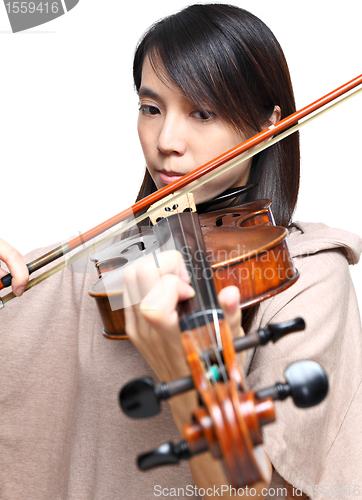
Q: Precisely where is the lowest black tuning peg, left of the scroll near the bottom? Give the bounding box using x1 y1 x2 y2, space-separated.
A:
137 441 193 470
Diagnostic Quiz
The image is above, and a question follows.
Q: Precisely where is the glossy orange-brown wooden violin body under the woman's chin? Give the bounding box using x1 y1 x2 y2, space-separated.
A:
90 199 298 340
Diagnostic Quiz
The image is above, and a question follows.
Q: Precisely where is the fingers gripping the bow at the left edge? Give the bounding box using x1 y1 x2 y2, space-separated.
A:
0 238 29 297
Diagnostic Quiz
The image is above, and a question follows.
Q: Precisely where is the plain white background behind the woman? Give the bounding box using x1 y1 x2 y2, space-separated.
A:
0 0 362 304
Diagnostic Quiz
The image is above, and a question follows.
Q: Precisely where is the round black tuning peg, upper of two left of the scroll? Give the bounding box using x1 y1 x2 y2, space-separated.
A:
119 377 194 418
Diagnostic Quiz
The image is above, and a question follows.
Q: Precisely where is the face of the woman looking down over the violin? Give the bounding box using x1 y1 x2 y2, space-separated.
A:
138 57 253 203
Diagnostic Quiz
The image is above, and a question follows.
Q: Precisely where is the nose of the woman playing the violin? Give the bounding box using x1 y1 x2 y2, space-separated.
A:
157 116 187 156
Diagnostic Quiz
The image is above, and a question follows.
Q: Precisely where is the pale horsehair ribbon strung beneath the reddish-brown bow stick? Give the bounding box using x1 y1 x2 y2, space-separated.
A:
0 87 362 308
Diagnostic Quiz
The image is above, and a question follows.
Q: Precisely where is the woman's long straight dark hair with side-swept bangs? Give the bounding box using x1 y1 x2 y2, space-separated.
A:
133 4 300 330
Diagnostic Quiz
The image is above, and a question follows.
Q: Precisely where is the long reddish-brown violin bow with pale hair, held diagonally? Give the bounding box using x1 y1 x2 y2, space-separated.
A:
0 75 362 309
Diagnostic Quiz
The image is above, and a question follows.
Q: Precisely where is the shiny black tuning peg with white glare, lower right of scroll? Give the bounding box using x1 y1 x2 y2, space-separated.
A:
256 361 328 408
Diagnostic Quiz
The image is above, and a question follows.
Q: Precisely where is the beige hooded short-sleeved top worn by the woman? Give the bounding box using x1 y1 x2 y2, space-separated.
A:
0 224 362 500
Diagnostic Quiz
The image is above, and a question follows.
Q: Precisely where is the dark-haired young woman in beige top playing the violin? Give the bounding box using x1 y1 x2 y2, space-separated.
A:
0 4 362 500
